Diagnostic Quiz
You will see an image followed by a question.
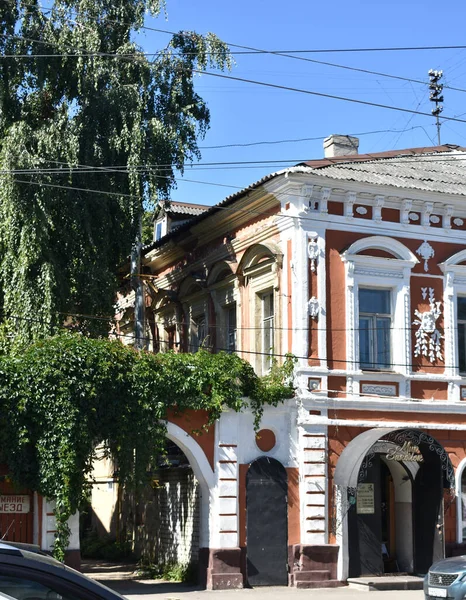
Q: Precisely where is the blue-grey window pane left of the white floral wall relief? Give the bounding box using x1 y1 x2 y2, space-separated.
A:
359 288 392 370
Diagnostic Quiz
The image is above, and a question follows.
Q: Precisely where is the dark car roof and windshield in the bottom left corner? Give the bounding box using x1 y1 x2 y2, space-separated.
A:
0 542 123 600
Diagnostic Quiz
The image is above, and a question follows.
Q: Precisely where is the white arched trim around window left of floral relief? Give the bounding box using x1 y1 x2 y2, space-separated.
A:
336 236 419 375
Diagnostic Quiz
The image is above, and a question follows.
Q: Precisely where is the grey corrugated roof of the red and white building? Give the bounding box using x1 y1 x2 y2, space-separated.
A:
144 144 466 252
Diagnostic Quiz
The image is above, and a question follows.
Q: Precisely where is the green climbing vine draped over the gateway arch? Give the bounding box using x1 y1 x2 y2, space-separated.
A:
0 334 293 558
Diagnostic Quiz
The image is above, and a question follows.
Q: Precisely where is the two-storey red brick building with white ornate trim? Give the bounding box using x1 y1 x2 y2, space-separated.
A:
115 136 466 588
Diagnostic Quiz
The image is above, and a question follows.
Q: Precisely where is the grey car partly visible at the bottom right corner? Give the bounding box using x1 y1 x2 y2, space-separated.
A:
424 556 466 600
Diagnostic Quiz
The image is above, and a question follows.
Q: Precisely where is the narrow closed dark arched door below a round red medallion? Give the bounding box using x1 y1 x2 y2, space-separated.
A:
246 456 288 586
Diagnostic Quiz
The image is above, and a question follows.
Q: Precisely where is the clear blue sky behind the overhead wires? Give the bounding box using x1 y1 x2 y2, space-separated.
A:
139 0 466 204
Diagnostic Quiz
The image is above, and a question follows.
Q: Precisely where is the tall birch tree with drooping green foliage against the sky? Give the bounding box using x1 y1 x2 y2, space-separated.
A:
0 0 230 343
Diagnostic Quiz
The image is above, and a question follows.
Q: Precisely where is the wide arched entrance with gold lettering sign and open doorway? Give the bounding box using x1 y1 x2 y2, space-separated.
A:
334 429 455 578
